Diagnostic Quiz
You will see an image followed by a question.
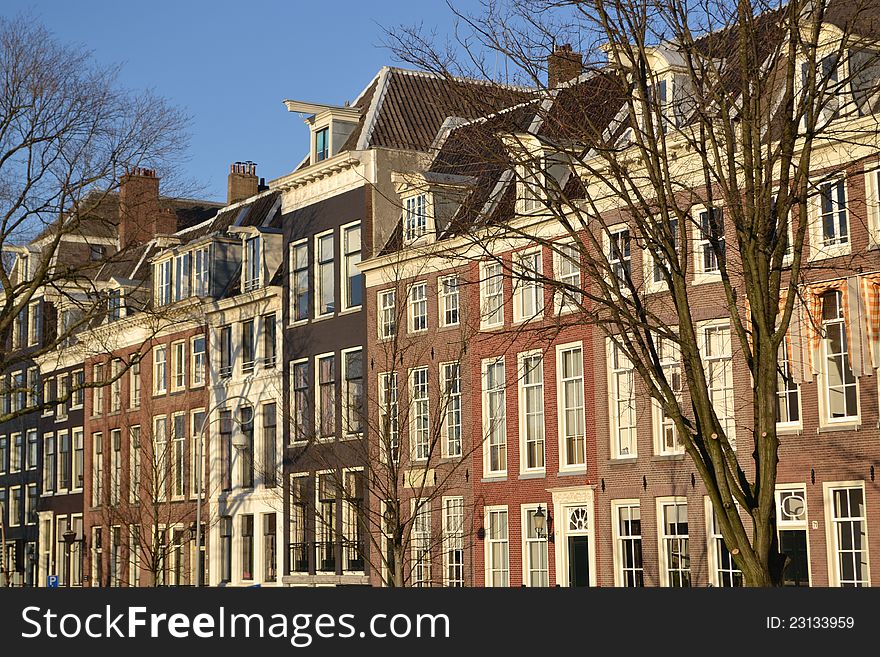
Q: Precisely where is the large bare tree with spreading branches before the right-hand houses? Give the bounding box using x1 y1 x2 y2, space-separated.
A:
389 0 880 586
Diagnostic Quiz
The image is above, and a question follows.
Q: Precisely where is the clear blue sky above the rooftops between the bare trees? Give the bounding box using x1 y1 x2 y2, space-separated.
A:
0 0 479 200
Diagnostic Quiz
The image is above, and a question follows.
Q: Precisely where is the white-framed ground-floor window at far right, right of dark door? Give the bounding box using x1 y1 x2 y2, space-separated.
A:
828 484 871 587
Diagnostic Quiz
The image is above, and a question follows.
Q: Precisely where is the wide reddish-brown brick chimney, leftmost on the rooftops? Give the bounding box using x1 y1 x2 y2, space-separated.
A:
119 167 177 248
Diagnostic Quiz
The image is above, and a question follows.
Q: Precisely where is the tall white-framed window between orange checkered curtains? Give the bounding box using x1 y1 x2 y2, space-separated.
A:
822 290 859 422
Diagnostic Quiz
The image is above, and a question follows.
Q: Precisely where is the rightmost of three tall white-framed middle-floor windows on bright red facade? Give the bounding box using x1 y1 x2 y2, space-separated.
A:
556 344 586 467
